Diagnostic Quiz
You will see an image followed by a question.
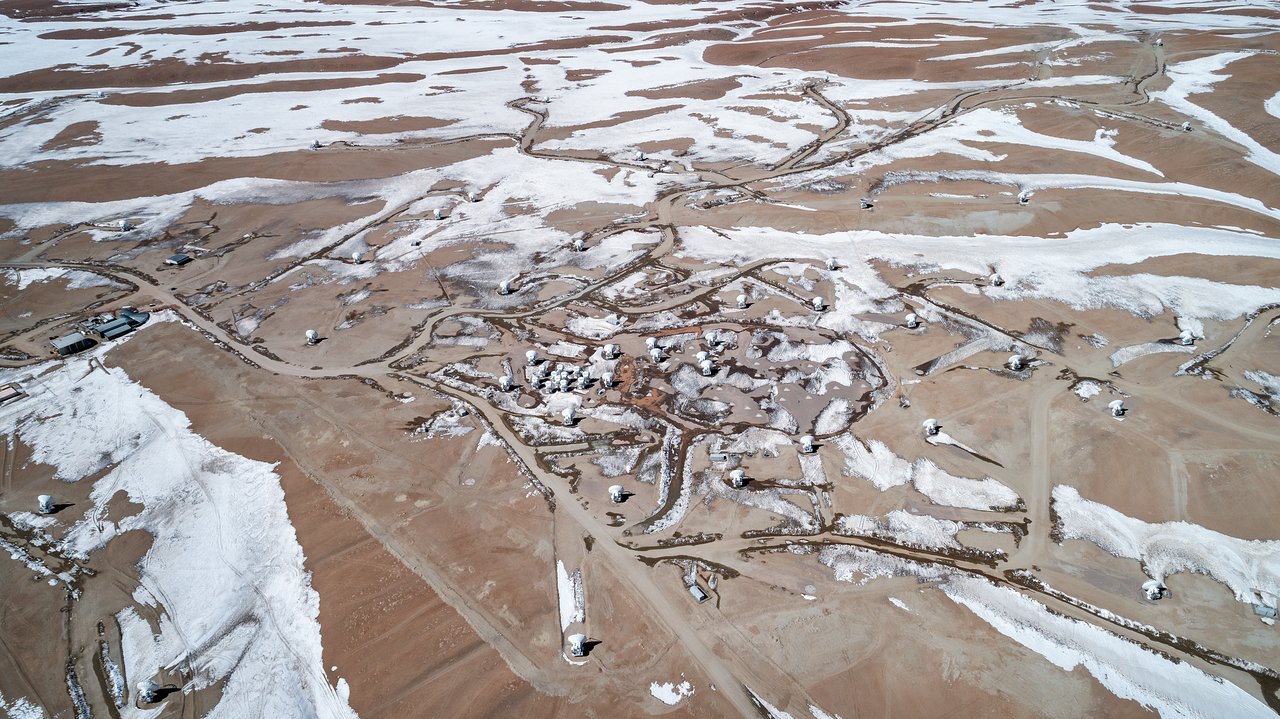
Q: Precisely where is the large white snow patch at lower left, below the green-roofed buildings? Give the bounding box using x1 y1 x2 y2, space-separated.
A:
0 329 355 718
